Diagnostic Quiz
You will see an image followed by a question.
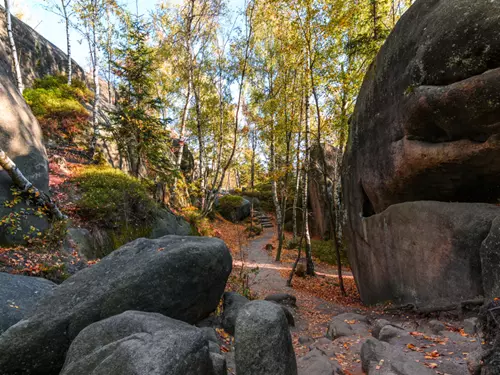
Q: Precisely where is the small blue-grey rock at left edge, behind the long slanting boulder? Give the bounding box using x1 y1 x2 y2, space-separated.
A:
0 272 57 334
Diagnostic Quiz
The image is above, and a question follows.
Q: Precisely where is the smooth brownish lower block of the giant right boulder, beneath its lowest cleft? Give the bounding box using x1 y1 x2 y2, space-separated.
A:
349 201 500 304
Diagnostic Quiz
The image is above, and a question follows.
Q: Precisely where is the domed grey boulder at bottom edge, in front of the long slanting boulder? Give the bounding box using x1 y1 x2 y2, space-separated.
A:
61 311 220 375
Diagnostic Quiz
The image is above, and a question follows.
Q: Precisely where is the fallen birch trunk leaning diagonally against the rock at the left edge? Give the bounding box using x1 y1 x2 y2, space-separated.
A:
0 149 67 220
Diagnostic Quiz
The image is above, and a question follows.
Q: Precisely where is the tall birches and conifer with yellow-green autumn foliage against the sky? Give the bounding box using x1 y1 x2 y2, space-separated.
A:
5 0 412 275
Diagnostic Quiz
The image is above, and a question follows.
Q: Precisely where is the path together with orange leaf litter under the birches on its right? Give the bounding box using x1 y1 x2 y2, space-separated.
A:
225 229 481 375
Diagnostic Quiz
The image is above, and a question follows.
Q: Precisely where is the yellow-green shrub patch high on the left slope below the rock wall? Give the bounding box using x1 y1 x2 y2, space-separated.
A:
23 75 93 142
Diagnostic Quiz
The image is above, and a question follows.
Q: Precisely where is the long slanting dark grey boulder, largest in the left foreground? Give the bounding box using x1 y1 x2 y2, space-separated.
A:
0 236 232 374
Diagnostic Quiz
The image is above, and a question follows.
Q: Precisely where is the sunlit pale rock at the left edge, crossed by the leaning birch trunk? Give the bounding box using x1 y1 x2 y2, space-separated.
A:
0 67 49 245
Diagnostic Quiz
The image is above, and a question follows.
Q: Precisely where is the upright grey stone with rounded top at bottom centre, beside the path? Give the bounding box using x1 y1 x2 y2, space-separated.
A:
235 301 297 375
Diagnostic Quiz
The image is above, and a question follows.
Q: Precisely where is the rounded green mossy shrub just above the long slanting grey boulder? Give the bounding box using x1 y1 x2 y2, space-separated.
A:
75 166 156 231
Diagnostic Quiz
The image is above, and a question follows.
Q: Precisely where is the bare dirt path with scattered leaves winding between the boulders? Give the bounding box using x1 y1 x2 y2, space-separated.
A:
240 229 480 375
